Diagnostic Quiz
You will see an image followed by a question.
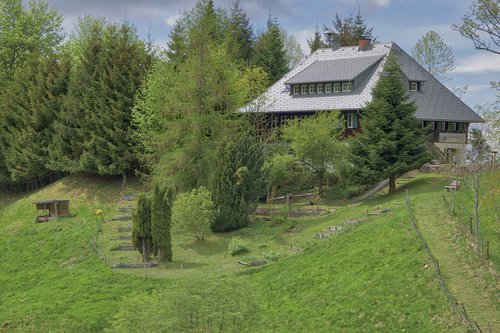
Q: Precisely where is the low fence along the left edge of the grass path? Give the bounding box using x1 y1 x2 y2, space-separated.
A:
405 190 491 333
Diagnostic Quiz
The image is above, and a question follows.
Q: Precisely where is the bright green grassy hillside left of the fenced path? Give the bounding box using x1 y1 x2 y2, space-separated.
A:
0 175 496 332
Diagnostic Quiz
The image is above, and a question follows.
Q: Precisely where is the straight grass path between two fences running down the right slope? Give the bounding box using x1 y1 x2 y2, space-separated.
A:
414 193 500 332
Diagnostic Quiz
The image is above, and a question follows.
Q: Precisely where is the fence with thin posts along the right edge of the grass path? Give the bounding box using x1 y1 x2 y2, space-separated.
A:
442 194 490 260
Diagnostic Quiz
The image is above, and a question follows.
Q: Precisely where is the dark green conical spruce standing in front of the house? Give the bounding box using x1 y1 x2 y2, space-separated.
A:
350 58 429 192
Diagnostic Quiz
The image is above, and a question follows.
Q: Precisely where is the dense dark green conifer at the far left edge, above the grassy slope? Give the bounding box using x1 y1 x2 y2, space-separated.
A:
0 55 68 182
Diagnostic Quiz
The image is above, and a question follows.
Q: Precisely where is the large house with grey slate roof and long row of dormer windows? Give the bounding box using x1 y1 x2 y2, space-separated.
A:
240 38 484 164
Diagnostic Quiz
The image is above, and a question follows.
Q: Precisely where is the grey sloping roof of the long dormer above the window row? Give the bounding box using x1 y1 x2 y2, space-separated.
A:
286 55 384 84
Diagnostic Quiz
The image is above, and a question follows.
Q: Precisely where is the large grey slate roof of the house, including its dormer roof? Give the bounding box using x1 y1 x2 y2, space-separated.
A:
238 43 484 123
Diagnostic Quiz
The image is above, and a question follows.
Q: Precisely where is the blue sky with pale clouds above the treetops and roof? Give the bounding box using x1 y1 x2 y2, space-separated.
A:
35 0 500 109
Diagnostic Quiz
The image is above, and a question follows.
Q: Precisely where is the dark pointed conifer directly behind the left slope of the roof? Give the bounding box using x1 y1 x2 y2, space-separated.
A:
252 17 288 84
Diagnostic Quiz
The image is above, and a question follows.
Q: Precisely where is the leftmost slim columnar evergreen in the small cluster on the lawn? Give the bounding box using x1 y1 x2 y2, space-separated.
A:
132 194 153 262
